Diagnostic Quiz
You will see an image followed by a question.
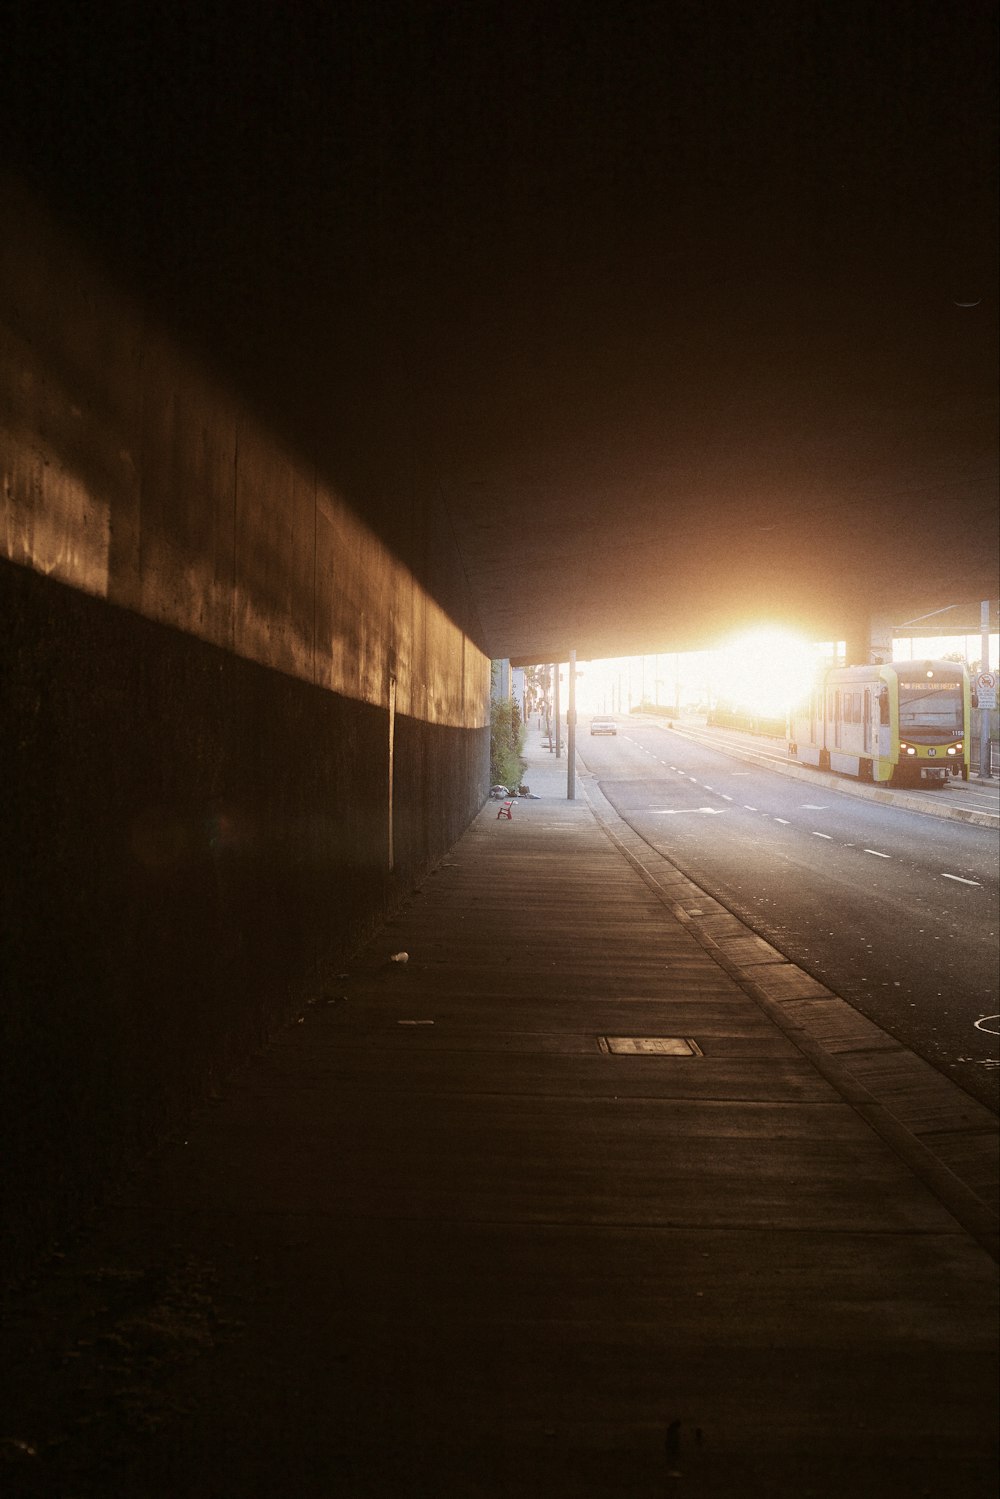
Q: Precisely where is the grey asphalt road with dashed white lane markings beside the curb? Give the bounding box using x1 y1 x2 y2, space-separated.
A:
577 724 1000 1109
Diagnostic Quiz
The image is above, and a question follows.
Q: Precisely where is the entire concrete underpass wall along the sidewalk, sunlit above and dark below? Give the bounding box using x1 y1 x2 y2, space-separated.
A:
0 187 489 1274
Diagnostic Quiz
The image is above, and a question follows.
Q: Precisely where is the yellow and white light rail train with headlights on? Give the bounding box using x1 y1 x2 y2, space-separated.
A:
789 661 972 785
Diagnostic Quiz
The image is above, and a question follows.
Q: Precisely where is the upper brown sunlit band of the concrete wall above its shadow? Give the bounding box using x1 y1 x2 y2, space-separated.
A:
0 183 489 729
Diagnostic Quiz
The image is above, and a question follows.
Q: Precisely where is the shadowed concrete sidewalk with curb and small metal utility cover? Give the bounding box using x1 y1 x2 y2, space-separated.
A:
7 735 997 1499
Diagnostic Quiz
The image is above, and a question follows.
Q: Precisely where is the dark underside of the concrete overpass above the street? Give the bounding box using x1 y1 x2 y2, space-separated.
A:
3 0 997 660
